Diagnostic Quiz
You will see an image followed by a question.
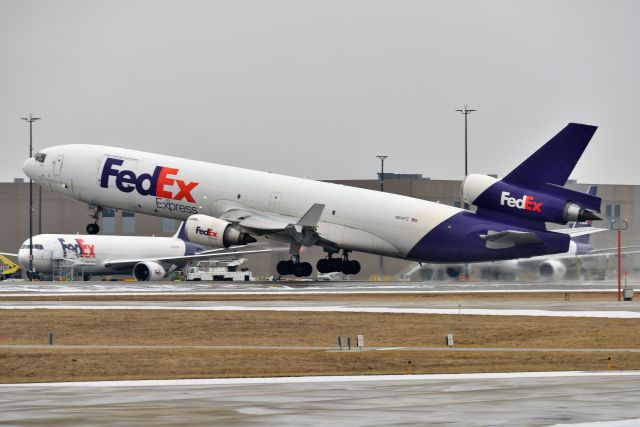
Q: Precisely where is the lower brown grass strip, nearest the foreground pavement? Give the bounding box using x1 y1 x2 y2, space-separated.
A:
0 348 640 383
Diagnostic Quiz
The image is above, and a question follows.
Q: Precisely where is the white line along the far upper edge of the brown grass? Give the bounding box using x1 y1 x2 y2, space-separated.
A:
0 304 640 319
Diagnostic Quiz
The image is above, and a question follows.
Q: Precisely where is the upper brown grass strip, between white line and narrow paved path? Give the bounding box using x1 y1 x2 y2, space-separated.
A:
0 310 640 348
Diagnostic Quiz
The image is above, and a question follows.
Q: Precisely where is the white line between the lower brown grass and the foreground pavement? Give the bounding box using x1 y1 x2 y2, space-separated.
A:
0 371 640 388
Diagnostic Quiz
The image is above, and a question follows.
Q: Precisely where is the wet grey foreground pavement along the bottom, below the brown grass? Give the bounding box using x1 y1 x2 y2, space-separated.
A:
0 371 640 427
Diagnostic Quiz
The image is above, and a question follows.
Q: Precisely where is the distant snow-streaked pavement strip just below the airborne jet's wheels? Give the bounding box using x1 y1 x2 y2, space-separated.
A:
0 281 617 296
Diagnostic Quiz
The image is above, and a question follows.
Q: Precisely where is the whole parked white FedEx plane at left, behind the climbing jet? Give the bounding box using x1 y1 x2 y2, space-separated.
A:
0 224 267 281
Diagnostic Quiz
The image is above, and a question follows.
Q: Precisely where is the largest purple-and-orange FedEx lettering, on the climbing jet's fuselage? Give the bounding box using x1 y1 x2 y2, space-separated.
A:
100 157 199 203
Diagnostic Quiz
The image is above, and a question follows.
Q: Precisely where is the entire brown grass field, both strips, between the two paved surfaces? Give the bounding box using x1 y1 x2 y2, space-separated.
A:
0 310 640 383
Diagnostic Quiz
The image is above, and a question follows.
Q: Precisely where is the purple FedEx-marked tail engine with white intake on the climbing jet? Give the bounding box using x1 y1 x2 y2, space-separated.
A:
461 174 601 224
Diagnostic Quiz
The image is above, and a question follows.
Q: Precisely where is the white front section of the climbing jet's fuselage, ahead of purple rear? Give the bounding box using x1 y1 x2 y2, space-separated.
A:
23 145 461 258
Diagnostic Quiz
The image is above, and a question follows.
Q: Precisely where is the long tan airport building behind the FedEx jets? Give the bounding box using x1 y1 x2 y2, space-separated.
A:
0 173 640 280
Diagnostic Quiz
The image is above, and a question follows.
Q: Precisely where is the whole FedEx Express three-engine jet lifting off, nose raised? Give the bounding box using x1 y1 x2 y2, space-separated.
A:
23 123 600 276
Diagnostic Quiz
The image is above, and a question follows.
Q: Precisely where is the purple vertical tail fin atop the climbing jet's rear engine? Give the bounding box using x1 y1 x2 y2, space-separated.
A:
503 123 597 186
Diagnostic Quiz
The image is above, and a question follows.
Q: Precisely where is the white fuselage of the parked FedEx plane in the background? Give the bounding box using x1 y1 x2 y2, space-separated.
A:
18 234 186 276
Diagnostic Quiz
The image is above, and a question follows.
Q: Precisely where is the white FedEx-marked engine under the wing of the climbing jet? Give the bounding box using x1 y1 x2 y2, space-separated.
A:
184 214 256 248
